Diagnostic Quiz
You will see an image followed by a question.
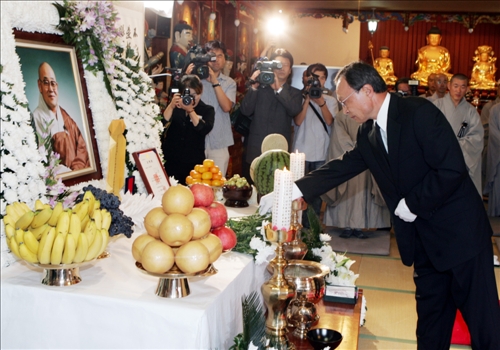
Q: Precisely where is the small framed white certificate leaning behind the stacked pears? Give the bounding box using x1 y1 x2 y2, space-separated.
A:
132 148 170 198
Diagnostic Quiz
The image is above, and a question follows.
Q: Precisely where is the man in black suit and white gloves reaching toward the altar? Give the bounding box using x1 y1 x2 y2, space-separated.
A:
262 62 500 350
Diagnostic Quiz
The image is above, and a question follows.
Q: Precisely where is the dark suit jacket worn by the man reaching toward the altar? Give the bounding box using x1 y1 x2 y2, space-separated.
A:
296 94 493 271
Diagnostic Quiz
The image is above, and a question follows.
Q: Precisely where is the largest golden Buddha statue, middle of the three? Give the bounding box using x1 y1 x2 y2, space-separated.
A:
411 27 452 86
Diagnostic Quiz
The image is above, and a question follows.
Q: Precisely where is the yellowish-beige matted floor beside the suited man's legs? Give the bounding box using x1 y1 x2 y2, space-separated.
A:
348 231 500 350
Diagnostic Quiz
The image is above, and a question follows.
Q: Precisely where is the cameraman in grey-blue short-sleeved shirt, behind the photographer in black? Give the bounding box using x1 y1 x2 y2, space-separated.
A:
186 40 236 176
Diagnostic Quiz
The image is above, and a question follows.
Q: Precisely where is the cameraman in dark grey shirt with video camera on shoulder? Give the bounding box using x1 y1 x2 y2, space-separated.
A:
240 49 302 179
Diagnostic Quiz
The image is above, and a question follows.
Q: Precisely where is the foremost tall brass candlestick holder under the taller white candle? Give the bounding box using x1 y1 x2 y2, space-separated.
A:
261 224 295 350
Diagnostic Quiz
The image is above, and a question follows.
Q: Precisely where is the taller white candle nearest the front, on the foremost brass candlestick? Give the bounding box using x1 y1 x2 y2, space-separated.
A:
273 168 293 231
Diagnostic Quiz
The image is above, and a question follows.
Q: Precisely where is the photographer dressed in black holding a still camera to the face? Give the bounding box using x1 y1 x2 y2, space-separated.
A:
162 75 215 185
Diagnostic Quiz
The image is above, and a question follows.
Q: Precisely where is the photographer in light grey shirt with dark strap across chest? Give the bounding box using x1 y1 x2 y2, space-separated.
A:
292 63 338 227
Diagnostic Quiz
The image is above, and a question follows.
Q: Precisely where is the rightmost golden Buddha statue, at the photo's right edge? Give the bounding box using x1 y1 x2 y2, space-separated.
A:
469 45 497 90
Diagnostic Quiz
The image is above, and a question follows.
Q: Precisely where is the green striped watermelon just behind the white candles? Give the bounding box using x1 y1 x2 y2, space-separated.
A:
253 149 290 196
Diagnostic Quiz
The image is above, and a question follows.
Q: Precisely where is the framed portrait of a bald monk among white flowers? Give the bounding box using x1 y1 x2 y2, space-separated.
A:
16 37 100 185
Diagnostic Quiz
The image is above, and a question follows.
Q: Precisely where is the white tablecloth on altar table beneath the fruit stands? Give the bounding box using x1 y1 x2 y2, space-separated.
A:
1 208 265 349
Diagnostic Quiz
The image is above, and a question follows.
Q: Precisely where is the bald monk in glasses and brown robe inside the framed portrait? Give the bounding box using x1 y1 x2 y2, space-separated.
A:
33 62 90 170
